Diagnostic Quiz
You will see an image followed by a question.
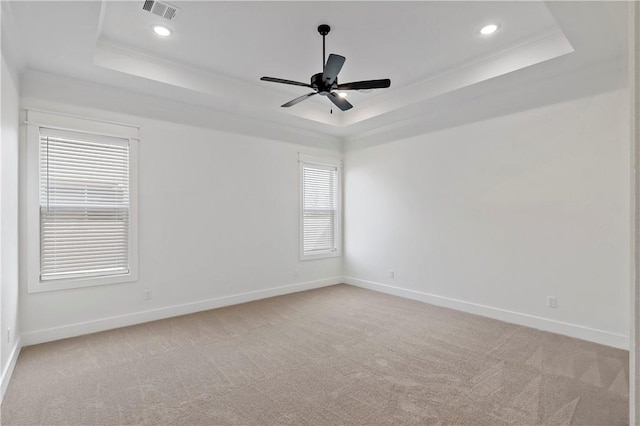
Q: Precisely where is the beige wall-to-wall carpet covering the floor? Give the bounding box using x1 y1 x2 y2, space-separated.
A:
2 285 628 425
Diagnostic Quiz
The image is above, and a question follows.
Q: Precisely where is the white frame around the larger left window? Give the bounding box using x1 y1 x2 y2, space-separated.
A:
24 109 139 293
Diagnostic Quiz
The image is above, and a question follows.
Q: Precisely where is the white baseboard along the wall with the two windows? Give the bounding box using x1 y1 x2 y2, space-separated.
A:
22 277 342 346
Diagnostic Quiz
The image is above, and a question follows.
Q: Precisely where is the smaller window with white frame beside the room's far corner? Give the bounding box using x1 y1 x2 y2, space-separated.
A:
300 154 341 260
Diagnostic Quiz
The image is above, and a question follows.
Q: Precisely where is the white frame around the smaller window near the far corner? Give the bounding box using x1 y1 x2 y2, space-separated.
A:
298 153 342 260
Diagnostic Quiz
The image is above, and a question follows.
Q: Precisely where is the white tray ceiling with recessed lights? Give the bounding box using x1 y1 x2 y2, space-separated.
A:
3 0 627 140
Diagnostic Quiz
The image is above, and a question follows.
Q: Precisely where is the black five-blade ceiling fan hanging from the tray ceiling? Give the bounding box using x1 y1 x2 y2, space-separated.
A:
260 24 391 111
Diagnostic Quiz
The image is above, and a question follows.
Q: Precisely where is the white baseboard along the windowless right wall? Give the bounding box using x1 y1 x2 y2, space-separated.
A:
344 277 629 350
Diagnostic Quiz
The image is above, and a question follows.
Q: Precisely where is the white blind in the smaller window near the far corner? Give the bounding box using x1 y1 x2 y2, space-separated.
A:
302 164 338 254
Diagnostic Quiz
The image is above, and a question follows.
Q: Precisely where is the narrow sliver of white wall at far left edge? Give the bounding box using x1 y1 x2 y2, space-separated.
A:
0 56 20 394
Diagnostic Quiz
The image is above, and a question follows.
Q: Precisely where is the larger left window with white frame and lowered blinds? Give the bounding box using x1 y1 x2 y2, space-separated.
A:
27 111 137 292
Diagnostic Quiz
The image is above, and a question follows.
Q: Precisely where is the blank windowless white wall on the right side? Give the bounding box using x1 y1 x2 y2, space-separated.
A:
345 90 631 347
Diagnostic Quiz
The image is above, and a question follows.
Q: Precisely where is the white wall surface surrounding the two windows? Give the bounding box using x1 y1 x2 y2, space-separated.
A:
20 95 342 344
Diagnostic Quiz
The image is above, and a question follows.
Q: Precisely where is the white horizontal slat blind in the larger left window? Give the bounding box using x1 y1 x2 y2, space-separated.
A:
39 128 131 281
